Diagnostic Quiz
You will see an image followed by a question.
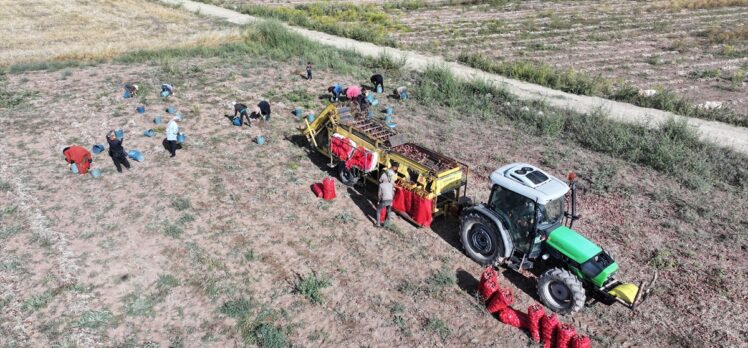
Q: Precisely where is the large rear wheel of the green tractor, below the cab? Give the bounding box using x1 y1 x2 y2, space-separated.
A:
460 212 505 266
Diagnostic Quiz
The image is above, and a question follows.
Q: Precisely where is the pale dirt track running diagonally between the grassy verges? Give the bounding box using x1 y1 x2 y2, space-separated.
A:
161 0 748 154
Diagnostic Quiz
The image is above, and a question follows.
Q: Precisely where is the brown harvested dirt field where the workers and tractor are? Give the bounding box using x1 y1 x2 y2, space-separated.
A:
0 47 748 347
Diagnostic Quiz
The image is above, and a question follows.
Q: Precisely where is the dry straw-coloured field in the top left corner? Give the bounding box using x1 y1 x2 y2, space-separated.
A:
0 0 240 66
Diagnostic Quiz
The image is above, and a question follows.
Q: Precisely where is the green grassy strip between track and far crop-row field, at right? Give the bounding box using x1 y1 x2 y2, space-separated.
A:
458 53 748 127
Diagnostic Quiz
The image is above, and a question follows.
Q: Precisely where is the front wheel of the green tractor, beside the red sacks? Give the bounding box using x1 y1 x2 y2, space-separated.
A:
538 268 587 314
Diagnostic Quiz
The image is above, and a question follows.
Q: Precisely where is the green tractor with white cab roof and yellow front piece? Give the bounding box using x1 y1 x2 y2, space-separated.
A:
460 163 656 314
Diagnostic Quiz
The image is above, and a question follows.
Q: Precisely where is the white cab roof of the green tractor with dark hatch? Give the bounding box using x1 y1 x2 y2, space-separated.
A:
491 163 569 205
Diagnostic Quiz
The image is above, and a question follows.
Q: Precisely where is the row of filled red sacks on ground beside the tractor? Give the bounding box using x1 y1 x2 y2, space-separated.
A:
478 266 591 348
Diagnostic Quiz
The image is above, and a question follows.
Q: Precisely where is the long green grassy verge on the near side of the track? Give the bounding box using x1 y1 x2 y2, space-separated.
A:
2 22 748 190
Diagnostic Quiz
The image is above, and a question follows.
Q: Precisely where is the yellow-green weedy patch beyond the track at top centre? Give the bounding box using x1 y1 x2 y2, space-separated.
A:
229 3 407 47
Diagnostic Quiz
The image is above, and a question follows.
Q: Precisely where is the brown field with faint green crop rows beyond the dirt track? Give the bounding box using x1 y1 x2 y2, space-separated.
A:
399 0 748 114
